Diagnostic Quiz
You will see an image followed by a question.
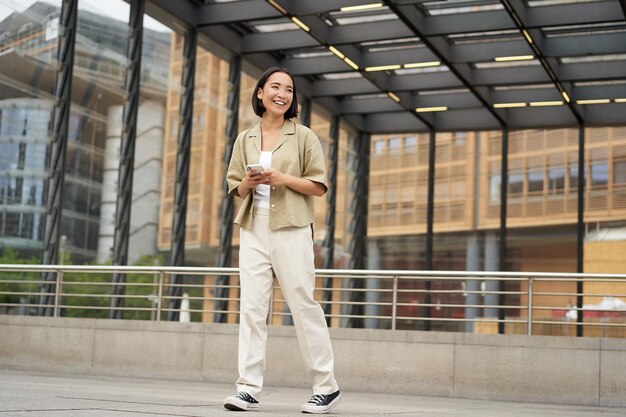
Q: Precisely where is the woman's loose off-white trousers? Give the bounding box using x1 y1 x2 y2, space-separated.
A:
236 208 338 400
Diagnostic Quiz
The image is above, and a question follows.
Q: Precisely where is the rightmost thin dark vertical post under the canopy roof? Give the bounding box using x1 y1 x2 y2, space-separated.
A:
576 124 586 337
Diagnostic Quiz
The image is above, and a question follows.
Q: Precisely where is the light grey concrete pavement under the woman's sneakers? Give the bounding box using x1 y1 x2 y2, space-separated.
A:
0 369 626 417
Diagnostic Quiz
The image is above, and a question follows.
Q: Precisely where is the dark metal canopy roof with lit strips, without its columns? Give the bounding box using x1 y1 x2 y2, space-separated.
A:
141 0 626 134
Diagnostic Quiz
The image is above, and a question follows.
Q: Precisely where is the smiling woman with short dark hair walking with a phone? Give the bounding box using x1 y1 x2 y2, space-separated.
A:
224 67 341 414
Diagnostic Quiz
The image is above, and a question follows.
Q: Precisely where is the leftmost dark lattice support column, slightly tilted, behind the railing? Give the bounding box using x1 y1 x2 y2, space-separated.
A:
38 0 78 316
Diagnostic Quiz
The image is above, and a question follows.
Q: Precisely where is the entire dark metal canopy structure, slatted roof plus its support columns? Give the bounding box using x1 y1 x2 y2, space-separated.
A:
33 0 626 332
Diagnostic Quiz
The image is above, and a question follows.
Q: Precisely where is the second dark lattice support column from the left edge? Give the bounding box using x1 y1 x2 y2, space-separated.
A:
109 0 145 319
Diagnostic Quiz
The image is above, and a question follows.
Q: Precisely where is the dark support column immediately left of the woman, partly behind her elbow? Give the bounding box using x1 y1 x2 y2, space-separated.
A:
214 55 241 323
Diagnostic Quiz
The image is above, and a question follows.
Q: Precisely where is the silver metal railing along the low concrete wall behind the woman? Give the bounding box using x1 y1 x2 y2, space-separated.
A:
0 265 626 337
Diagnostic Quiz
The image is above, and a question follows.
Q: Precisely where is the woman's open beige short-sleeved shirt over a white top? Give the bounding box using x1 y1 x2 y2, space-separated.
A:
226 120 328 230
